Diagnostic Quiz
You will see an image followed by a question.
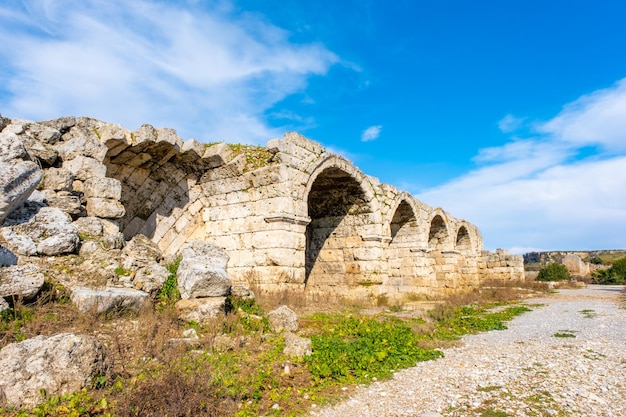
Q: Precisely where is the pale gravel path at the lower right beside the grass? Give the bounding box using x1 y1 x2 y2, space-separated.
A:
311 286 626 417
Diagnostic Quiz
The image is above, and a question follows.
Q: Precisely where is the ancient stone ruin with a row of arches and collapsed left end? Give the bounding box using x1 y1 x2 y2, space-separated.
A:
0 117 524 302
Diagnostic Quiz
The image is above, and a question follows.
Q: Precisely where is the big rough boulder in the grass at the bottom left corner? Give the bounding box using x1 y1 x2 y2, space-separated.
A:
0 333 105 407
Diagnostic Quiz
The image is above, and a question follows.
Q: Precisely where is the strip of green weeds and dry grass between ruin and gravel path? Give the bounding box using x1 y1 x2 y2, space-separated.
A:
0 280 529 417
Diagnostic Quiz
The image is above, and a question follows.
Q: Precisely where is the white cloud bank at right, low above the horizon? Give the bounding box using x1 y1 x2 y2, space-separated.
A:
418 79 626 251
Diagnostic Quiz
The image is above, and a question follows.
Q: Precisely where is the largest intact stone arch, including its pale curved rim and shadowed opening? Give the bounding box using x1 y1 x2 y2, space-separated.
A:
304 156 381 288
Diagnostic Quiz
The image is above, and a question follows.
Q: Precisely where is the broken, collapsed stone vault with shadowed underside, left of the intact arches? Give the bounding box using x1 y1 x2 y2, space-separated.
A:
103 125 206 253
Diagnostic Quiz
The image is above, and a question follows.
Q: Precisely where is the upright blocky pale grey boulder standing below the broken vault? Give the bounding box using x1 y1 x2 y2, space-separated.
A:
177 241 232 299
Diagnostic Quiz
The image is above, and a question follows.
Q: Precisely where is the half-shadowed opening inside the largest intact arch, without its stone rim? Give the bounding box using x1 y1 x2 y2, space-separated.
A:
305 167 371 286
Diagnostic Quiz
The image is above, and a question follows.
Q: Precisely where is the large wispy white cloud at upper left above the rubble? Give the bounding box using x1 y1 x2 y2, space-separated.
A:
0 0 339 143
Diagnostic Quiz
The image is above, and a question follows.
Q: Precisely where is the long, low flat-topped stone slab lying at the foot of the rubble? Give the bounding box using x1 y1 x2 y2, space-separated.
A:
70 287 150 314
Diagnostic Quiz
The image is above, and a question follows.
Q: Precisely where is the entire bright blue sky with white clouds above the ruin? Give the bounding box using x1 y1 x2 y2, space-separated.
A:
0 0 626 253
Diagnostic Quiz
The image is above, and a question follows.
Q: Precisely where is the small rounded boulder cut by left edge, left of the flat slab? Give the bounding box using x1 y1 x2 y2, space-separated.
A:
0 264 44 300
